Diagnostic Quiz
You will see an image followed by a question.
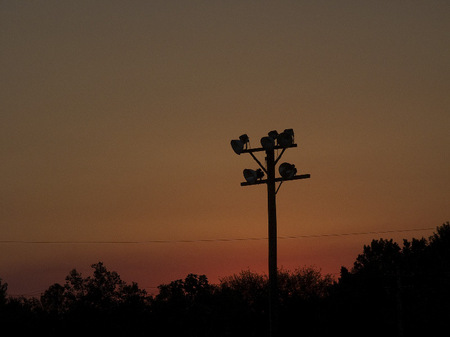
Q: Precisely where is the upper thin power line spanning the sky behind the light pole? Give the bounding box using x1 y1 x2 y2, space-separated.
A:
0 227 435 245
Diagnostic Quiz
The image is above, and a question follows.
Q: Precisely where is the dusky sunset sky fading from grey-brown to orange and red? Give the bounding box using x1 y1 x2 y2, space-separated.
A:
0 0 450 294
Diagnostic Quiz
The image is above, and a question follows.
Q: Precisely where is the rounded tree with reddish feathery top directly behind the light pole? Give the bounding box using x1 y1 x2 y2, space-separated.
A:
217 267 333 336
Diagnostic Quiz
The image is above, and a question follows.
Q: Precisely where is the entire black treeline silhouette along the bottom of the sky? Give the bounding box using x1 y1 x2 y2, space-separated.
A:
0 222 450 337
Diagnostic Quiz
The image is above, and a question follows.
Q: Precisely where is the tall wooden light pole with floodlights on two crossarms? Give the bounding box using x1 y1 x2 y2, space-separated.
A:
231 129 310 337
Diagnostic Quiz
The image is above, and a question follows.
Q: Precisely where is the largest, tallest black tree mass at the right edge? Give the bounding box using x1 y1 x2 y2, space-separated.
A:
331 222 450 336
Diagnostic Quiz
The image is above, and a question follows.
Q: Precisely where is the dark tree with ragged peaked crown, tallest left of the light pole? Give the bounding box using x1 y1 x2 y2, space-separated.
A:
41 262 149 335
